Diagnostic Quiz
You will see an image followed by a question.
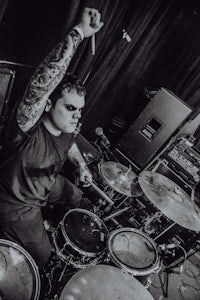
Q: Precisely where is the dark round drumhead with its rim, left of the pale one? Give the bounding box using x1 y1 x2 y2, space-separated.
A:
61 209 108 256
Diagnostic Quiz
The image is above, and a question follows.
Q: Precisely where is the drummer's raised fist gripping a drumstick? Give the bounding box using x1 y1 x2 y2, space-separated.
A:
77 7 104 38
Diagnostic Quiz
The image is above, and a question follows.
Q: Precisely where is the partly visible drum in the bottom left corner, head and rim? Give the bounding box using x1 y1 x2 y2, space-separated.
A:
0 239 40 300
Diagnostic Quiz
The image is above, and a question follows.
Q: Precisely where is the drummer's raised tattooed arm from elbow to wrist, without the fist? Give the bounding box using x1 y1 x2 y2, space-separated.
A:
17 30 81 132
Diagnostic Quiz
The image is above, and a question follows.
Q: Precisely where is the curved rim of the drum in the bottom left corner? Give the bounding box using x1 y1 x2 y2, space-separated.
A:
0 239 41 300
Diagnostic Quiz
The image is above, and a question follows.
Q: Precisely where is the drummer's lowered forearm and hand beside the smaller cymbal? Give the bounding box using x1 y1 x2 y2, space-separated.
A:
68 143 92 183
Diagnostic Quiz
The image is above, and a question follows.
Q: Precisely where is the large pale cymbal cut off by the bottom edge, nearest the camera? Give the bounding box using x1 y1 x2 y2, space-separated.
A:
59 265 154 300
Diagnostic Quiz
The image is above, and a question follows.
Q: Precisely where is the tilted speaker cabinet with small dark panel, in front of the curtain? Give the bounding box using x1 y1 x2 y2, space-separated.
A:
118 88 192 170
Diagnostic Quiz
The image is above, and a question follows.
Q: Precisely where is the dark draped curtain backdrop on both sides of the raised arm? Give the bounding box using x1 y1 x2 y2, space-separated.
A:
0 0 200 139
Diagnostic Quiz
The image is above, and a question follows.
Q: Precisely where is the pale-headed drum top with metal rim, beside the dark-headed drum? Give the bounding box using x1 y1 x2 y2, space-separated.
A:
108 228 158 275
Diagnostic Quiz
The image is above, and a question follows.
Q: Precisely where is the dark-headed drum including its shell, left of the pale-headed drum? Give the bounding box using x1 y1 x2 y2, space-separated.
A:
53 208 108 269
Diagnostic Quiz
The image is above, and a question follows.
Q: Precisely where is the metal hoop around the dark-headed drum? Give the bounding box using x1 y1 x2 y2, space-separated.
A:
60 208 108 257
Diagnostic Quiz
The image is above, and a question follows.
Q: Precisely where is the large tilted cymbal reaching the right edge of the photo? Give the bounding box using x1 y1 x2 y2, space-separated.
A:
138 171 200 231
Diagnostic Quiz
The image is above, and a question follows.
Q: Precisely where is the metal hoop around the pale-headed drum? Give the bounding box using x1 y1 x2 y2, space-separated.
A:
107 227 160 275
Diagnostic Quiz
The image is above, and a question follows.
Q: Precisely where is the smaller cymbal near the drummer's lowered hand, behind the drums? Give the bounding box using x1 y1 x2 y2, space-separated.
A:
100 161 141 197
